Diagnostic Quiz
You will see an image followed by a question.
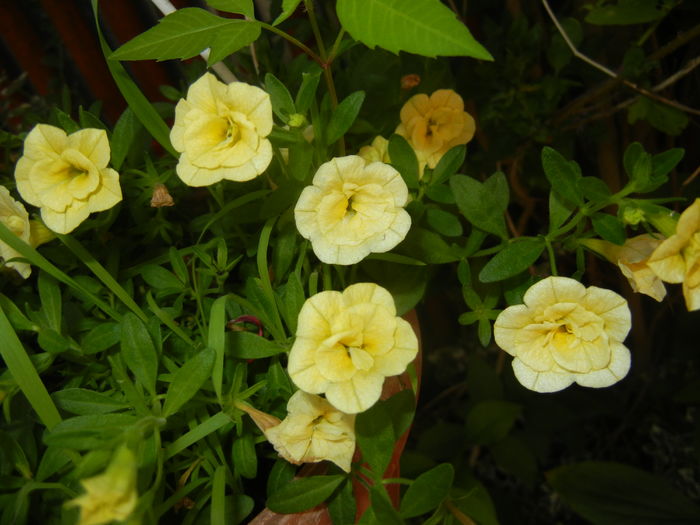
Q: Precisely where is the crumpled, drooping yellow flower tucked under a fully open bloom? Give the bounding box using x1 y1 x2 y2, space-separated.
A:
265 390 355 472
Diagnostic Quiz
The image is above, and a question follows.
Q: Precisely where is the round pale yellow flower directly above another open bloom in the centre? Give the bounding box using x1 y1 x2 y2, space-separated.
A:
294 155 411 264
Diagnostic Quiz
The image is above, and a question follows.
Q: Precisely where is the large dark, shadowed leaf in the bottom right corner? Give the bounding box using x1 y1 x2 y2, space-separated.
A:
547 461 700 525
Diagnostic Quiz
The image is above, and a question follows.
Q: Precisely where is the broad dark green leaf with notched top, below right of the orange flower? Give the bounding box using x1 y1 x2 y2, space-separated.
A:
450 171 510 239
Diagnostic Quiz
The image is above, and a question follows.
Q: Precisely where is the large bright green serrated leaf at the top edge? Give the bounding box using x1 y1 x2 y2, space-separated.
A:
336 0 493 60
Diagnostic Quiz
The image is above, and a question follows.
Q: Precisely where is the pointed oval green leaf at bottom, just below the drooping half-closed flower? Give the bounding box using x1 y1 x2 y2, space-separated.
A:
267 475 345 514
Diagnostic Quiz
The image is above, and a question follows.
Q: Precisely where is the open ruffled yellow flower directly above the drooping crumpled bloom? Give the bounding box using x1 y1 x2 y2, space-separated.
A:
287 283 418 414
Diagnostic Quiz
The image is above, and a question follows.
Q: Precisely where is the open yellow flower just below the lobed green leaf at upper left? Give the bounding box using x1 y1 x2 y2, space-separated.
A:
170 73 272 186
